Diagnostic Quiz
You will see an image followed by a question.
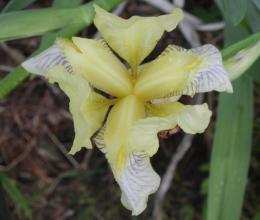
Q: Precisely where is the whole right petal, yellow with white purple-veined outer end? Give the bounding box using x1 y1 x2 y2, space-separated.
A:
134 44 232 102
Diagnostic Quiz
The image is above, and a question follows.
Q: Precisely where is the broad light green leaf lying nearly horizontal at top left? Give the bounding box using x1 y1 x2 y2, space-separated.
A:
0 8 83 42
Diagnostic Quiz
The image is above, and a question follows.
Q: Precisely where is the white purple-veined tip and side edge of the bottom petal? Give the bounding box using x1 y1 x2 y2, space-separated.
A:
93 126 160 215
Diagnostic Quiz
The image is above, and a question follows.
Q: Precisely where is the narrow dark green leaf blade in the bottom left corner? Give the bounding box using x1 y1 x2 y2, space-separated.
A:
0 172 32 220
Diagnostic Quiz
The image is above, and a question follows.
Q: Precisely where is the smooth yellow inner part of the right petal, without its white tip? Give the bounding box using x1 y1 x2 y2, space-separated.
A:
134 50 202 100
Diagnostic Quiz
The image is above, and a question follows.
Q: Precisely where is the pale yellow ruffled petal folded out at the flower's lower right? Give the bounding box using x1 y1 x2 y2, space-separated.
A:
127 102 211 156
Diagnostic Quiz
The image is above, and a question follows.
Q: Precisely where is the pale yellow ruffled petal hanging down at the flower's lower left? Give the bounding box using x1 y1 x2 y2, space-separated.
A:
46 66 110 154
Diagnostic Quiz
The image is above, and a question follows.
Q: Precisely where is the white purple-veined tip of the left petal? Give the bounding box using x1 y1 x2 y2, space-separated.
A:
22 39 73 76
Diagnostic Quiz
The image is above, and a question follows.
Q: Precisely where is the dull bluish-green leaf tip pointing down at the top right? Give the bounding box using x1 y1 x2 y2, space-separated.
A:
216 0 248 25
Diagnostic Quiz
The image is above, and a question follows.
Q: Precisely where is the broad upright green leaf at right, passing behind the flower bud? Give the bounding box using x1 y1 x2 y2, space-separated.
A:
206 21 253 220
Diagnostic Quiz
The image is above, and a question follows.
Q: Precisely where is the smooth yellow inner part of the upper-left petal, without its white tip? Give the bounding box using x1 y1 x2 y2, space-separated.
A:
64 37 132 97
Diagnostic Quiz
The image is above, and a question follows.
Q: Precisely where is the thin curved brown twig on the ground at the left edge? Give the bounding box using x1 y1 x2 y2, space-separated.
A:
0 139 36 172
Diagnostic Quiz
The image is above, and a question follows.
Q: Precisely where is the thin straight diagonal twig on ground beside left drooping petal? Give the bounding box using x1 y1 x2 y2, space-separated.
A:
44 126 80 168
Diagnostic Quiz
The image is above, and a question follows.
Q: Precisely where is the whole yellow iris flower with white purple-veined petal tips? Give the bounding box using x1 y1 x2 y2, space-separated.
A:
23 6 232 215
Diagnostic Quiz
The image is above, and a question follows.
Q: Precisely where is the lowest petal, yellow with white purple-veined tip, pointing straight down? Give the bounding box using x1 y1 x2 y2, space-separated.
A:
94 96 160 215
